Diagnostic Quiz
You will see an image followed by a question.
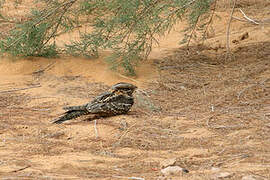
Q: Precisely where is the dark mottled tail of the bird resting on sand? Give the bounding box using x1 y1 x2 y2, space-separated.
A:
53 106 89 124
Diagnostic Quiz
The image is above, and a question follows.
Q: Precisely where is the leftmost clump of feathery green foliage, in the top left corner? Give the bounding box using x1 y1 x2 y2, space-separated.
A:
0 1 78 57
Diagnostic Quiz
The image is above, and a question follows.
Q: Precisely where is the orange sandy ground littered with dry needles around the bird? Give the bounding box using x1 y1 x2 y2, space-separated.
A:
0 0 270 180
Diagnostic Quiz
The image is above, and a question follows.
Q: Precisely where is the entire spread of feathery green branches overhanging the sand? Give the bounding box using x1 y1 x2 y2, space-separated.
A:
0 0 215 75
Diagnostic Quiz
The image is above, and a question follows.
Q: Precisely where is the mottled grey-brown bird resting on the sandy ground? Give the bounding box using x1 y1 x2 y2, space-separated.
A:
53 82 137 124
